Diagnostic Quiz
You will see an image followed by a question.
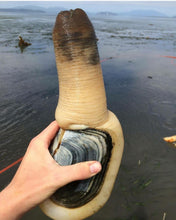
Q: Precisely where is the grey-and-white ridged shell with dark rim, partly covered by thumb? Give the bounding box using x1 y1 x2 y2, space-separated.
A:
50 129 112 208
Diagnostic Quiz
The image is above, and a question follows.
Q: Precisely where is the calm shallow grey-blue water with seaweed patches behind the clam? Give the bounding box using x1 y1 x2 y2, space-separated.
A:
0 13 176 220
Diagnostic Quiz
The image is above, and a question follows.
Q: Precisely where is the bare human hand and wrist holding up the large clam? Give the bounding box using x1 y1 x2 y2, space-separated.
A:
0 121 101 220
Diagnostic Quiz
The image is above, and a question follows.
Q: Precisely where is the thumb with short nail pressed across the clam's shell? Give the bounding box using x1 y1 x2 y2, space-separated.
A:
58 161 101 187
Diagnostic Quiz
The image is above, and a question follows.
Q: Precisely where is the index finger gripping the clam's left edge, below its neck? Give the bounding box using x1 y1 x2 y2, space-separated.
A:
37 121 59 147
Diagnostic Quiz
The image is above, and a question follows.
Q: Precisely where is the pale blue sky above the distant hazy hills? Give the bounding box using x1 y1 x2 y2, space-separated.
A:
0 1 176 16
